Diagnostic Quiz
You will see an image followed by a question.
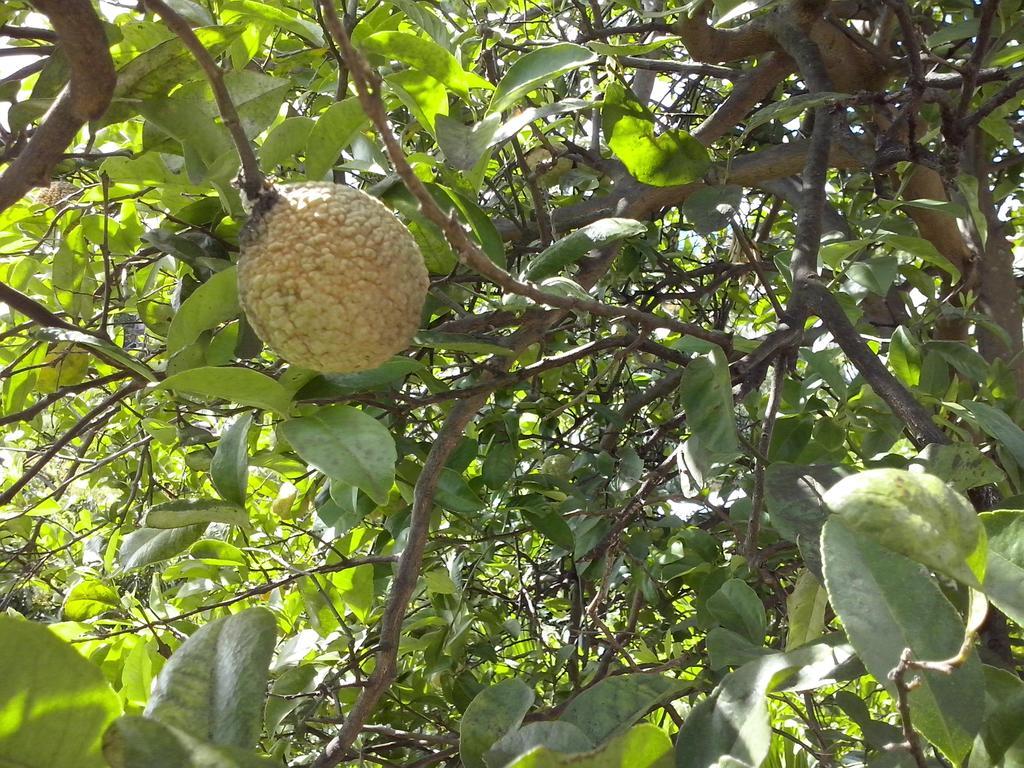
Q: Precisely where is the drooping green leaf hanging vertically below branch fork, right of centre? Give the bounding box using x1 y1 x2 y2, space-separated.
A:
679 348 739 457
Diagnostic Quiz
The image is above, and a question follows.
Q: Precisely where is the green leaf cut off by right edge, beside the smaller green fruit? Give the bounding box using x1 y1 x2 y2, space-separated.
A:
979 510 1024 626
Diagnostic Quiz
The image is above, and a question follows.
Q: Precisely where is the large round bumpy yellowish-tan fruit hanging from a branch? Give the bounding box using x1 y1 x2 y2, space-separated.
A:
239 181 429 373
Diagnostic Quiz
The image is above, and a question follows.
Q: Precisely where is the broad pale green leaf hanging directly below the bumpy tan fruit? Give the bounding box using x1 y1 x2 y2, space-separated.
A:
281 406 397 504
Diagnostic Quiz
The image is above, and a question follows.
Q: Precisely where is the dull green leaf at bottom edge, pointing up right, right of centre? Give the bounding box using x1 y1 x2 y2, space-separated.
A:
559 672 690 744
